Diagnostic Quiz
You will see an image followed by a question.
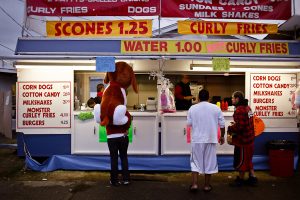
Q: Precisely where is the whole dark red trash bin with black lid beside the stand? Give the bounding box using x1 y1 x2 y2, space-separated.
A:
267 140 296 177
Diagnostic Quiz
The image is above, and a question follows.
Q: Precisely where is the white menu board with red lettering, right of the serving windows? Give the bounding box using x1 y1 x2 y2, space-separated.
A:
250 73 297 118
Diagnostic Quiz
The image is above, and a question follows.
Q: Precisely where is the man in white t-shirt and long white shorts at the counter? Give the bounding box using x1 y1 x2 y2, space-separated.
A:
187 89 225 192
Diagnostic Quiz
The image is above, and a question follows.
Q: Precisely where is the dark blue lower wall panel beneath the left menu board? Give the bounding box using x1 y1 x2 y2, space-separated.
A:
17 133 71 157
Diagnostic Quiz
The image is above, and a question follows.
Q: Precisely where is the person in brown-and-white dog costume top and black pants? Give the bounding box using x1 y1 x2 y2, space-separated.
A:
95 62 138 186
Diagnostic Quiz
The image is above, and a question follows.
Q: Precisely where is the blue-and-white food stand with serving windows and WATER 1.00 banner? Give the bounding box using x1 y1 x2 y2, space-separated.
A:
15 38 300 171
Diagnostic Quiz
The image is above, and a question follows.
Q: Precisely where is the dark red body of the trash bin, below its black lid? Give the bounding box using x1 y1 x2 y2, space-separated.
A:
269 149 294 177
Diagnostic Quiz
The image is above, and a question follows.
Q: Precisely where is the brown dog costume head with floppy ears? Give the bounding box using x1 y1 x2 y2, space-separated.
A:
104 62 138 93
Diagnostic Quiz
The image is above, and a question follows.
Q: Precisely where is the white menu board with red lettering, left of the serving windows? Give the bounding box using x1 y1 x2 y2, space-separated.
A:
17 81 71 129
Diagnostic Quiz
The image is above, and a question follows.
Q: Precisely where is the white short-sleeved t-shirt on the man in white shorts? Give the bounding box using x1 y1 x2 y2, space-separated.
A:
187 101 225 143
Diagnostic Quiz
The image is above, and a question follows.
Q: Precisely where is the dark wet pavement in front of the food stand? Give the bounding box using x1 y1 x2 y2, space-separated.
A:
0 135 300 200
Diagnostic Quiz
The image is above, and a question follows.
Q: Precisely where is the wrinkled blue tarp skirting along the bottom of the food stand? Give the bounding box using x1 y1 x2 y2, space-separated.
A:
25 155 298 172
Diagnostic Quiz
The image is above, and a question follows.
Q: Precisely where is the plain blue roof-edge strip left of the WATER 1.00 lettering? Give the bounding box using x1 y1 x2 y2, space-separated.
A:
16 39 121 54
